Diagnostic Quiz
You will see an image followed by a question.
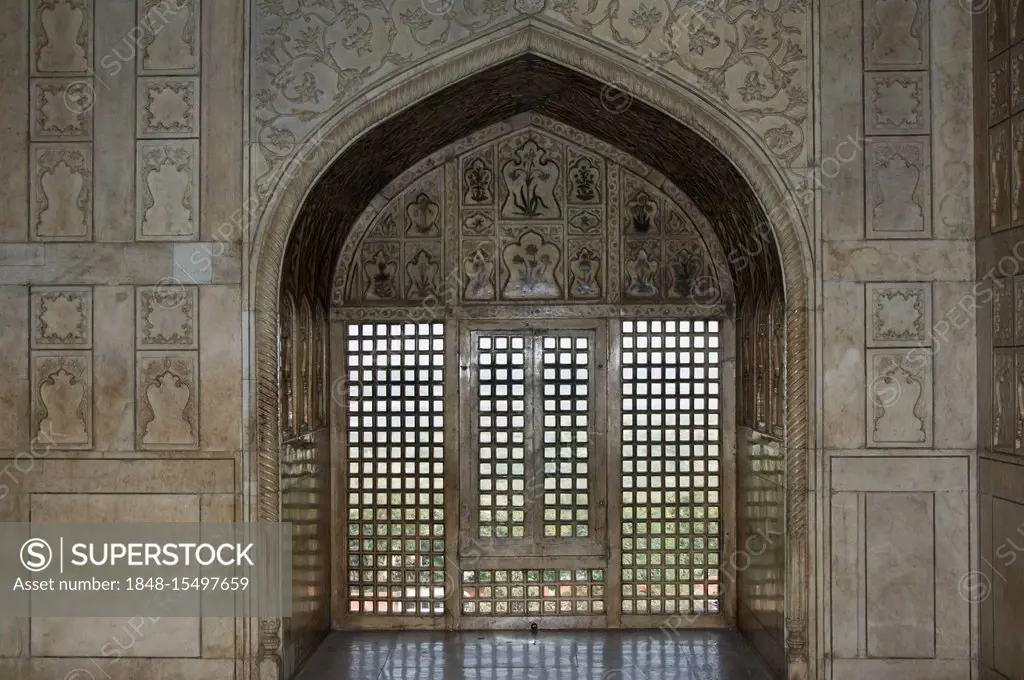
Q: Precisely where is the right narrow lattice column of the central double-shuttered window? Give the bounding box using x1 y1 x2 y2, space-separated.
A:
542 335 591 538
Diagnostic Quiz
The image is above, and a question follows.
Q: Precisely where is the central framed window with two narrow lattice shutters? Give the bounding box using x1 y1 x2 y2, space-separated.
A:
460 323 607 561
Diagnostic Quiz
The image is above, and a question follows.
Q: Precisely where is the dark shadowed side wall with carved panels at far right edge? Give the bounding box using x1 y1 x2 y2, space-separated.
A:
965 0 1024 679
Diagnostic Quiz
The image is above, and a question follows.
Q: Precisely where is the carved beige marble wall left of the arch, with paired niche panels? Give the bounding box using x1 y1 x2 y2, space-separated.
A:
0 0 245 680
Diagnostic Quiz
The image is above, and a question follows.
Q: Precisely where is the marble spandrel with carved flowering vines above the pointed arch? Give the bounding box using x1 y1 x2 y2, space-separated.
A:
252 0 810 208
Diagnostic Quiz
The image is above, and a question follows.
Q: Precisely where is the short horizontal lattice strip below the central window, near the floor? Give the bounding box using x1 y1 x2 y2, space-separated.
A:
462 569 604 617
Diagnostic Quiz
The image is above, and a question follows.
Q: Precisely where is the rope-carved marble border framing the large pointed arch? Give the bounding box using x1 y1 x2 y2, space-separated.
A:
244 20 815 680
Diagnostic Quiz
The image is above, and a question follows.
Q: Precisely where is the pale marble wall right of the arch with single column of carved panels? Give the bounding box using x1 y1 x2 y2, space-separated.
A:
816 0 981 680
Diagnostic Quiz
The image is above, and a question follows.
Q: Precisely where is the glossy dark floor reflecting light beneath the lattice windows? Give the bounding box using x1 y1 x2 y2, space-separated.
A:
298 630 771 680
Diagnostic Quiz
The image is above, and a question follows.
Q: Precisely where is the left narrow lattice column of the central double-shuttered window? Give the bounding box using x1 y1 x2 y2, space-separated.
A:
476 334 526 539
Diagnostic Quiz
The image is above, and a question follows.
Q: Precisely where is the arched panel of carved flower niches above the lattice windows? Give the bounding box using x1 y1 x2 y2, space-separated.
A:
333 114 732 313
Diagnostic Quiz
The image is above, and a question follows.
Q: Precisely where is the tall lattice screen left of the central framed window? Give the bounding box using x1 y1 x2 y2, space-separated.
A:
344 324 444 614
